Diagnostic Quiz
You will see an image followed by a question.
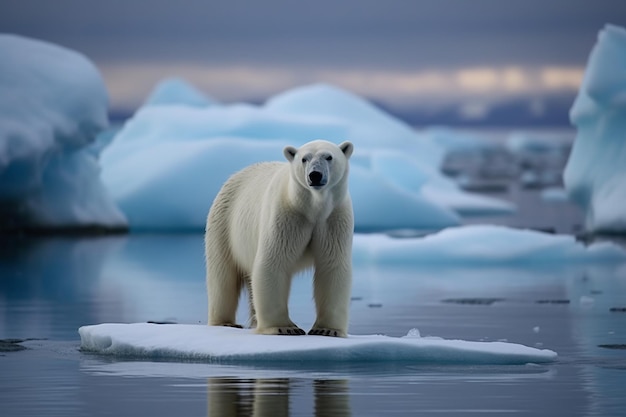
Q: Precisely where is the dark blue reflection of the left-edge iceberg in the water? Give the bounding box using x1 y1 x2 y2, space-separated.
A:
0 236 124 339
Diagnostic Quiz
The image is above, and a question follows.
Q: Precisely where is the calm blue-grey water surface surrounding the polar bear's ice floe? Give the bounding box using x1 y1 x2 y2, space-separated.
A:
0 231 626 416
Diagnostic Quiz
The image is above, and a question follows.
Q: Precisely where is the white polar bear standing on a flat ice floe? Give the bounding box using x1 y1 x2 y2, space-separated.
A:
205 140 354 337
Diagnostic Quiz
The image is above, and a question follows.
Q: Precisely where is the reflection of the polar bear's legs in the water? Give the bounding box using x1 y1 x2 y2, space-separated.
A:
207 378 351 417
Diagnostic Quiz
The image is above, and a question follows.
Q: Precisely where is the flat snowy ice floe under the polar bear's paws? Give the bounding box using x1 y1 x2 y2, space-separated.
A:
78 323 557 365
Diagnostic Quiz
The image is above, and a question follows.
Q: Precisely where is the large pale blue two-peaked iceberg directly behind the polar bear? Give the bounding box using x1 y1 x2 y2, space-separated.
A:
101 83 514 231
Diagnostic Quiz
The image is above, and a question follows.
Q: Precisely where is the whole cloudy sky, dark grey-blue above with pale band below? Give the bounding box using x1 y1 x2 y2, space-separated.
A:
0 0 626 122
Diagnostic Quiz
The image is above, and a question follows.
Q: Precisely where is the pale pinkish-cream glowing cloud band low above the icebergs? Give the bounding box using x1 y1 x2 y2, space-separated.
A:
100 61 584 110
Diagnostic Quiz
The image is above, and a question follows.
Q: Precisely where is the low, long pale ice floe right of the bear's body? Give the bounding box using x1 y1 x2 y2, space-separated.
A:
353 225 626 266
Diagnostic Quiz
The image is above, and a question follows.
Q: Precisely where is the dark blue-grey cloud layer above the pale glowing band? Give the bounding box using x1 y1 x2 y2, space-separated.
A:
0 0 626 68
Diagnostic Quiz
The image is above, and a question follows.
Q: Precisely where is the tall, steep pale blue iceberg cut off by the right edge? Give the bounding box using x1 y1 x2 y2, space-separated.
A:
564 25 626 233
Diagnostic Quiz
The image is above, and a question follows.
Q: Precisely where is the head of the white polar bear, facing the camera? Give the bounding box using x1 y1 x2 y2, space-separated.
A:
283 140 354 190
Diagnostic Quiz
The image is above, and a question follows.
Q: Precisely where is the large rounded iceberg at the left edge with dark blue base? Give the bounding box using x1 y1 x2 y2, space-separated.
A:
0 35 126 230
